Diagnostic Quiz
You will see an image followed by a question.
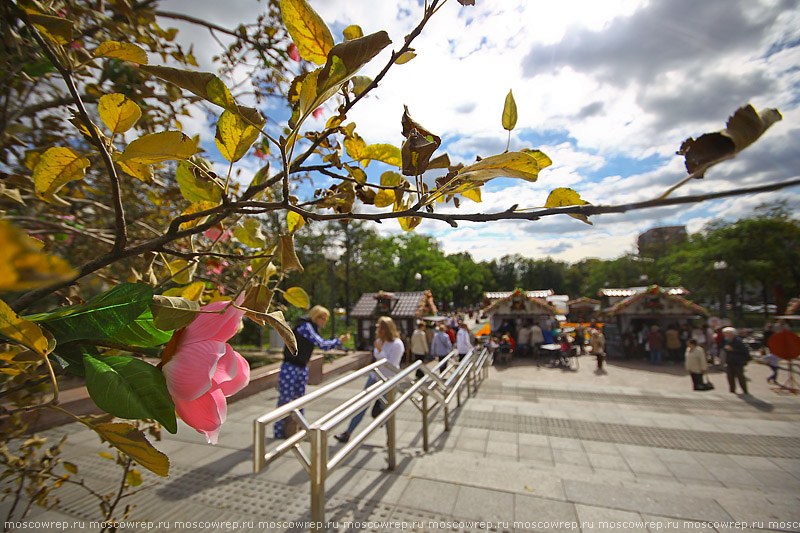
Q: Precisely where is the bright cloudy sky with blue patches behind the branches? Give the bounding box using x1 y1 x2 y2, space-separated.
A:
162 0 800 262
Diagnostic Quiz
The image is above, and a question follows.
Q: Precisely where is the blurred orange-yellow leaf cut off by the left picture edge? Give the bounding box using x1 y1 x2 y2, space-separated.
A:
0 221 76 291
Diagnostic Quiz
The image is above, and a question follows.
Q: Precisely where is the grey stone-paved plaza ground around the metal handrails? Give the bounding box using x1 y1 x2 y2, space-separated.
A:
6 357 800 532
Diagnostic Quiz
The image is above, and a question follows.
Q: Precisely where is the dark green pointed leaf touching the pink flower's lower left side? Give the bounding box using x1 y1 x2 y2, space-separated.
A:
83 355 178 433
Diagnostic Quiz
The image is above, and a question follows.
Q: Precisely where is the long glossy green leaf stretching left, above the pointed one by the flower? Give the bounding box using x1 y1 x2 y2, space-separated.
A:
29 283 153 344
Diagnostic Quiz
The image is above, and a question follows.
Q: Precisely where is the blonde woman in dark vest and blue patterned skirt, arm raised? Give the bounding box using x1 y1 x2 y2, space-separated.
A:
272 305 350 439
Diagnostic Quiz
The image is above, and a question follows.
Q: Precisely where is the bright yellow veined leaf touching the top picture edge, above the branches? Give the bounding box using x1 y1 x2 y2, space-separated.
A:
281 0 333 65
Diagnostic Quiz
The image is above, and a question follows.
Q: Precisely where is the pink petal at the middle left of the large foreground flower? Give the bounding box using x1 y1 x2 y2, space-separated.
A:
161 339 226 401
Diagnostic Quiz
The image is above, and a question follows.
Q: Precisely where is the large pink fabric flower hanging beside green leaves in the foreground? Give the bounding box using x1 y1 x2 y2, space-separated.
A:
161 302 250 444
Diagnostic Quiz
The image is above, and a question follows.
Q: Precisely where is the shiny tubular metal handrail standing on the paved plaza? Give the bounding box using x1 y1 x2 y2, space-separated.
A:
253 349 489 530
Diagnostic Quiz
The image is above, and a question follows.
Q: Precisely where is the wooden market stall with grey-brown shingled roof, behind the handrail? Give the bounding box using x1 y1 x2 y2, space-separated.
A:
350 291 438 350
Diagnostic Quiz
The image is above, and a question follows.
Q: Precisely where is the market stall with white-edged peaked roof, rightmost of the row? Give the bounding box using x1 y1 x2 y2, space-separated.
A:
600 285 710 357
